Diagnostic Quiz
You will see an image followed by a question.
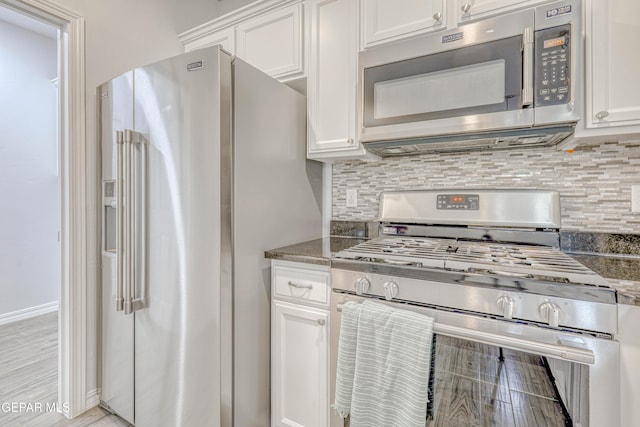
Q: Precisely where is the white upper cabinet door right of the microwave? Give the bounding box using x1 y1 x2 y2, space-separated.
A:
586 0 640 133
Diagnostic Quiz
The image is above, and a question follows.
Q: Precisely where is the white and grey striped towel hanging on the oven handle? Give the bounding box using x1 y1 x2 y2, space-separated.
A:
334 301 433 427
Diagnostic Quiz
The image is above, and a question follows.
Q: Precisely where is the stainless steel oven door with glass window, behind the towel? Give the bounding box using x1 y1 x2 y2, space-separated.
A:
330 291 620 427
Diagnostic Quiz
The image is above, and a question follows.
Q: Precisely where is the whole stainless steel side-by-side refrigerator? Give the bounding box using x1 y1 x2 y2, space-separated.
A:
98 46 322 427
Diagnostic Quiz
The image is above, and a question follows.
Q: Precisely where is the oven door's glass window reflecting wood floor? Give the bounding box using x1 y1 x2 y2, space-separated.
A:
427 335 571 427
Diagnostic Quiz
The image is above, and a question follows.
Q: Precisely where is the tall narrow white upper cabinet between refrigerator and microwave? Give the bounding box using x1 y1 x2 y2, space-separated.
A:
307 0 366 160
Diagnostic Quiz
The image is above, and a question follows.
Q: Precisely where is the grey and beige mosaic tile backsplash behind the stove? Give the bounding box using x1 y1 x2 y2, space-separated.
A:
332 141 640 233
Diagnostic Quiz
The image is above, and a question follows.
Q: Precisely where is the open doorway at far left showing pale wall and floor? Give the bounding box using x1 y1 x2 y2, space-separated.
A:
0 8 61 425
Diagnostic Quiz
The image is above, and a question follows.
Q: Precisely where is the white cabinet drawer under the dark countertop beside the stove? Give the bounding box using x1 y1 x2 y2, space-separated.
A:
273 265 331 305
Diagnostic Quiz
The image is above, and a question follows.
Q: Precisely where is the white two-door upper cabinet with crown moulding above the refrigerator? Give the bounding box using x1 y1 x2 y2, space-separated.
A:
178 0 306 81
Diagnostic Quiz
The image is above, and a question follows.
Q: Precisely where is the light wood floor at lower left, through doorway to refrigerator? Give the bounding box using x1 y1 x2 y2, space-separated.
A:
0 313 129 427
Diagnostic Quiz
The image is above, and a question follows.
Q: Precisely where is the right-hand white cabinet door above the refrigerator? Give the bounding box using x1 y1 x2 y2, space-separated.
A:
236 3 304 79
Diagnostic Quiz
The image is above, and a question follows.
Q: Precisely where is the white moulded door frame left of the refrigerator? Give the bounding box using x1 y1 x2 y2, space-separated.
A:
0 0 87 418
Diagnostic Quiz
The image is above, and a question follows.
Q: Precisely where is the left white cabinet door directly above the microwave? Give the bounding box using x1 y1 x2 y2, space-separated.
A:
361 0 445 49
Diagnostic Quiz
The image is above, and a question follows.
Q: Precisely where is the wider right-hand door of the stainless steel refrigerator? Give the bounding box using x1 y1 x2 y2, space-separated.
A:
133 48 230 427
